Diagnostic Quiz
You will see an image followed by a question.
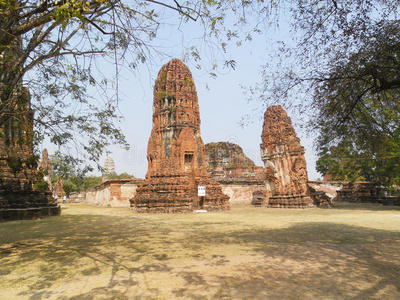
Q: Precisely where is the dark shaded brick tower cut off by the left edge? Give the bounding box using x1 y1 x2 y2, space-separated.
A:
0 37 60 221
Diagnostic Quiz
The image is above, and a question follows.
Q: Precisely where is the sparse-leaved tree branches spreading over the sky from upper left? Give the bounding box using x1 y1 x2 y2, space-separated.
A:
0 0 270 171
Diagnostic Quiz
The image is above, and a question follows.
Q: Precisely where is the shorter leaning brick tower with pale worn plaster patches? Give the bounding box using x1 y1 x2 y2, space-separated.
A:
261 105 313 208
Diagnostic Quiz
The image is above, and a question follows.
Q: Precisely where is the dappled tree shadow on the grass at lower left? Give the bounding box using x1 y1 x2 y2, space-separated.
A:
0 215 175 299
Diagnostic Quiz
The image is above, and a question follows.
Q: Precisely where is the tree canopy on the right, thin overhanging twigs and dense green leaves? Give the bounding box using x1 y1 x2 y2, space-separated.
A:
247 0 400 181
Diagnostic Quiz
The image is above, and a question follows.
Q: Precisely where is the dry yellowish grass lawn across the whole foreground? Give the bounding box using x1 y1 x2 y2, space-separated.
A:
0 204 400 300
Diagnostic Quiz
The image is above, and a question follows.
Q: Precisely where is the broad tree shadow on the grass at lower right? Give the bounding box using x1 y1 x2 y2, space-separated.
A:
175 222 400 299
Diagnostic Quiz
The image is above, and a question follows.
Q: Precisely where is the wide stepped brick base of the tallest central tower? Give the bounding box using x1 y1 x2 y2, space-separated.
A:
129 175 230 213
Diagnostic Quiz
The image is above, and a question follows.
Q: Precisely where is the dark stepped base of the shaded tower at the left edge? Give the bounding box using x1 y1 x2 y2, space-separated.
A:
0 191 61 222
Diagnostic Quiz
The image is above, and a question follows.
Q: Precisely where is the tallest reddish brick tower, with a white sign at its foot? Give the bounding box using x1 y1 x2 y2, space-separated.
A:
130 59 229 212
